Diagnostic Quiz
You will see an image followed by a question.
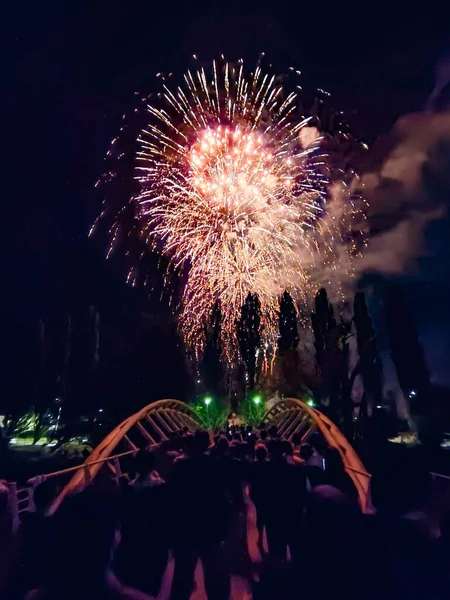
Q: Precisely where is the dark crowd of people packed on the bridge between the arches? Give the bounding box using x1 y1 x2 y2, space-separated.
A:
0 427 450 600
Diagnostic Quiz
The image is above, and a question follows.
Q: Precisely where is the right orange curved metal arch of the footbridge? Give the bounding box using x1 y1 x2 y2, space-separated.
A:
265 398 371 511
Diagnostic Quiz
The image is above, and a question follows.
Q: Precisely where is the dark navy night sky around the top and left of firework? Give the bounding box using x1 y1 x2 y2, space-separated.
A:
0 0 450 412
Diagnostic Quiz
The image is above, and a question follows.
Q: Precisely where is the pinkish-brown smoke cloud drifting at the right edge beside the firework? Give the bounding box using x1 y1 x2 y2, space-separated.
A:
357 109 450 275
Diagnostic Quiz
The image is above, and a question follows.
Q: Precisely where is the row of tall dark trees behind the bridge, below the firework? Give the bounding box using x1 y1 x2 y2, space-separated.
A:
199 286 450 442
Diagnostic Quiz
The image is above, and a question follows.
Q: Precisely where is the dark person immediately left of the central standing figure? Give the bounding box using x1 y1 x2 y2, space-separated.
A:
115 450 169 596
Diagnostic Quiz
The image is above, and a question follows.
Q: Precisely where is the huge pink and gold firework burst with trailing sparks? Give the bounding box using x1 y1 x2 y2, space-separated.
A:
96 57 368 364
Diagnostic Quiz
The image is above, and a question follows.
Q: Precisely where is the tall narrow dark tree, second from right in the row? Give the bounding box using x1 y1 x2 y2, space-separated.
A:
353 292 383 415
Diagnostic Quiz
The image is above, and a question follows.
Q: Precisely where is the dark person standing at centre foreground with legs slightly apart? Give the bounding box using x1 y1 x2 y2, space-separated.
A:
169 432 230 600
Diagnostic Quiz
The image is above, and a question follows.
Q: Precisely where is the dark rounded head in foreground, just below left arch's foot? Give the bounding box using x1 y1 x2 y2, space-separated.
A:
45 489 120 589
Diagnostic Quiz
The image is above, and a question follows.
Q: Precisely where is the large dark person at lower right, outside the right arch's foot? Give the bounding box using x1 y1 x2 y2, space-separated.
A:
366 450 449 600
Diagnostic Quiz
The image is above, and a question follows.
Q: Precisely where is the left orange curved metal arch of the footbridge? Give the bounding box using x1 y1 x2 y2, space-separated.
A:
48 399 201 514
